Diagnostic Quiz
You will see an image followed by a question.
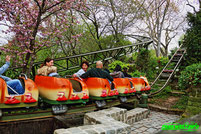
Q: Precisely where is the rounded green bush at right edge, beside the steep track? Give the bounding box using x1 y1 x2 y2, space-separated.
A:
179 63 201 90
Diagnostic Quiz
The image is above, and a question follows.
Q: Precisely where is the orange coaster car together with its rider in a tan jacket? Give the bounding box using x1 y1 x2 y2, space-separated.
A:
35 58 89 114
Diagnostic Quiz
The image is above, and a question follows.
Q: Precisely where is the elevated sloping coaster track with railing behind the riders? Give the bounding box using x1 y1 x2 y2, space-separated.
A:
9 35 153 78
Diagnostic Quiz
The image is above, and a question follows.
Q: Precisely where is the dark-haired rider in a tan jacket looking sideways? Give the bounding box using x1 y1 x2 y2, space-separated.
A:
37 58 58 76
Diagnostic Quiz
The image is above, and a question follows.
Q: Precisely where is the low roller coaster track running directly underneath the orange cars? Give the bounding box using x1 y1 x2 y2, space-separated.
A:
0 96 137 122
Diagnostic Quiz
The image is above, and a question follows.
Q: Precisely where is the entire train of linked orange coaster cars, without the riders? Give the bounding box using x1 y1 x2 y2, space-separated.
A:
0 75 150 115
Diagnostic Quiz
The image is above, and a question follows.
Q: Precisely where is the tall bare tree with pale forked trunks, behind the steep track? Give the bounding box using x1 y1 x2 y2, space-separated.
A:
136 0 185 56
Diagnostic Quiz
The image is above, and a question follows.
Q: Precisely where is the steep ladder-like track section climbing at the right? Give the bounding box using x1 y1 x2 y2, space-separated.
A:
148 45 186 97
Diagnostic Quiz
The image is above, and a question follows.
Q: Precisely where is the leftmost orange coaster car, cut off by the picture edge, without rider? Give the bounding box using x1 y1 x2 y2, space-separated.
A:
0 76 38 117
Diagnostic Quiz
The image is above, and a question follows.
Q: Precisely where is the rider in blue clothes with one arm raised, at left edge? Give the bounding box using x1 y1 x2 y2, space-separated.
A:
0 55 24 94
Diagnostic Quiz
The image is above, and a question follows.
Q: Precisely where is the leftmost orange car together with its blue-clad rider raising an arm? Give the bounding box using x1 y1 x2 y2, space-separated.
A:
0 55 38 110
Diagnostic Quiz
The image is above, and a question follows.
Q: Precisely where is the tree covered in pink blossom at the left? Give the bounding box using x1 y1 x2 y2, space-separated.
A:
0 0 84 75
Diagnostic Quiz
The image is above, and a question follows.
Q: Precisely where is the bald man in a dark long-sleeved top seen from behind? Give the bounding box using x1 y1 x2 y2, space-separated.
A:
80 61 113 82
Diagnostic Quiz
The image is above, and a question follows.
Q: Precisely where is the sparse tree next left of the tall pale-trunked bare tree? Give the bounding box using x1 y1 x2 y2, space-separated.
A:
103 0 145 44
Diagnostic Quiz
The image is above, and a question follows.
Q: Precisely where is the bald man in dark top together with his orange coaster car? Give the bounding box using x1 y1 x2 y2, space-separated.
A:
77 61 118 107
